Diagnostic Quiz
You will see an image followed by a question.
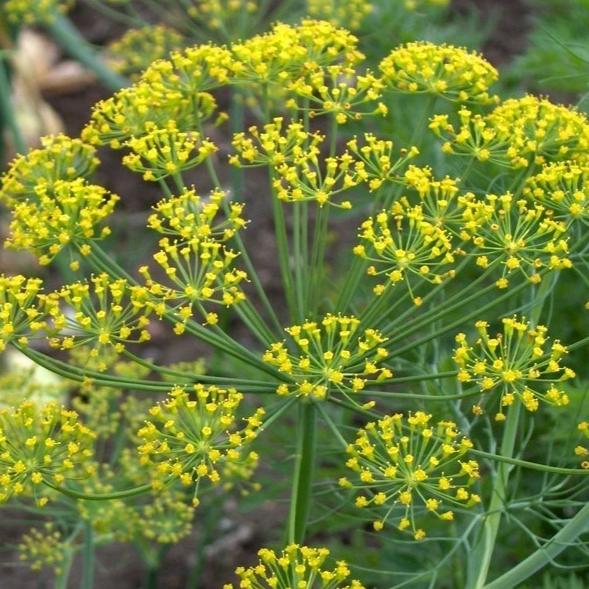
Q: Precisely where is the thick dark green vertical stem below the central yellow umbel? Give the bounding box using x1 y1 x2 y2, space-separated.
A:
288 402 316 544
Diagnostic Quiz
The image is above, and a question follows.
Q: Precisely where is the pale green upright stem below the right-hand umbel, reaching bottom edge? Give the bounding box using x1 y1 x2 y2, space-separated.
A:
467 403 521 589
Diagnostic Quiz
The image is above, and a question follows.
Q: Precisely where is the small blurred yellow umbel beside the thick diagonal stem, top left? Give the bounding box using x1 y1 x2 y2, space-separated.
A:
108 25 184 79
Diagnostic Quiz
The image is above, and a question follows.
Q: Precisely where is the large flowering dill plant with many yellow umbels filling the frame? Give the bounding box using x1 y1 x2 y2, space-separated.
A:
0 20 589 589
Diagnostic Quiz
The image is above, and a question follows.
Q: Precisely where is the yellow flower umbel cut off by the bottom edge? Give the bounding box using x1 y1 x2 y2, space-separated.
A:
223 544 364 589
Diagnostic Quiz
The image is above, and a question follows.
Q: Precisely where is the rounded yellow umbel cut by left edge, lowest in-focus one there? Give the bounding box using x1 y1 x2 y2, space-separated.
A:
0 402 95 505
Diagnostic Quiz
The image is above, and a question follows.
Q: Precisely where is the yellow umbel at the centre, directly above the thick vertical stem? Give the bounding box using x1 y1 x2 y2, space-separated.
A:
263 314 392 403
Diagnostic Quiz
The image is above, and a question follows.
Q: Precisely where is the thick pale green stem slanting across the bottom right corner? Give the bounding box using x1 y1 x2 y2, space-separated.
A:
484 505 589 589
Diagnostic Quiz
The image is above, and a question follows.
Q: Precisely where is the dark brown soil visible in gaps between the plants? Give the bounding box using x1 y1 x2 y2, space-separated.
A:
0 0 527 589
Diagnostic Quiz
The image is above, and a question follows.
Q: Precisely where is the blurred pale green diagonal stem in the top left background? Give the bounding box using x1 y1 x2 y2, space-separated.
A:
47 15 129 90
